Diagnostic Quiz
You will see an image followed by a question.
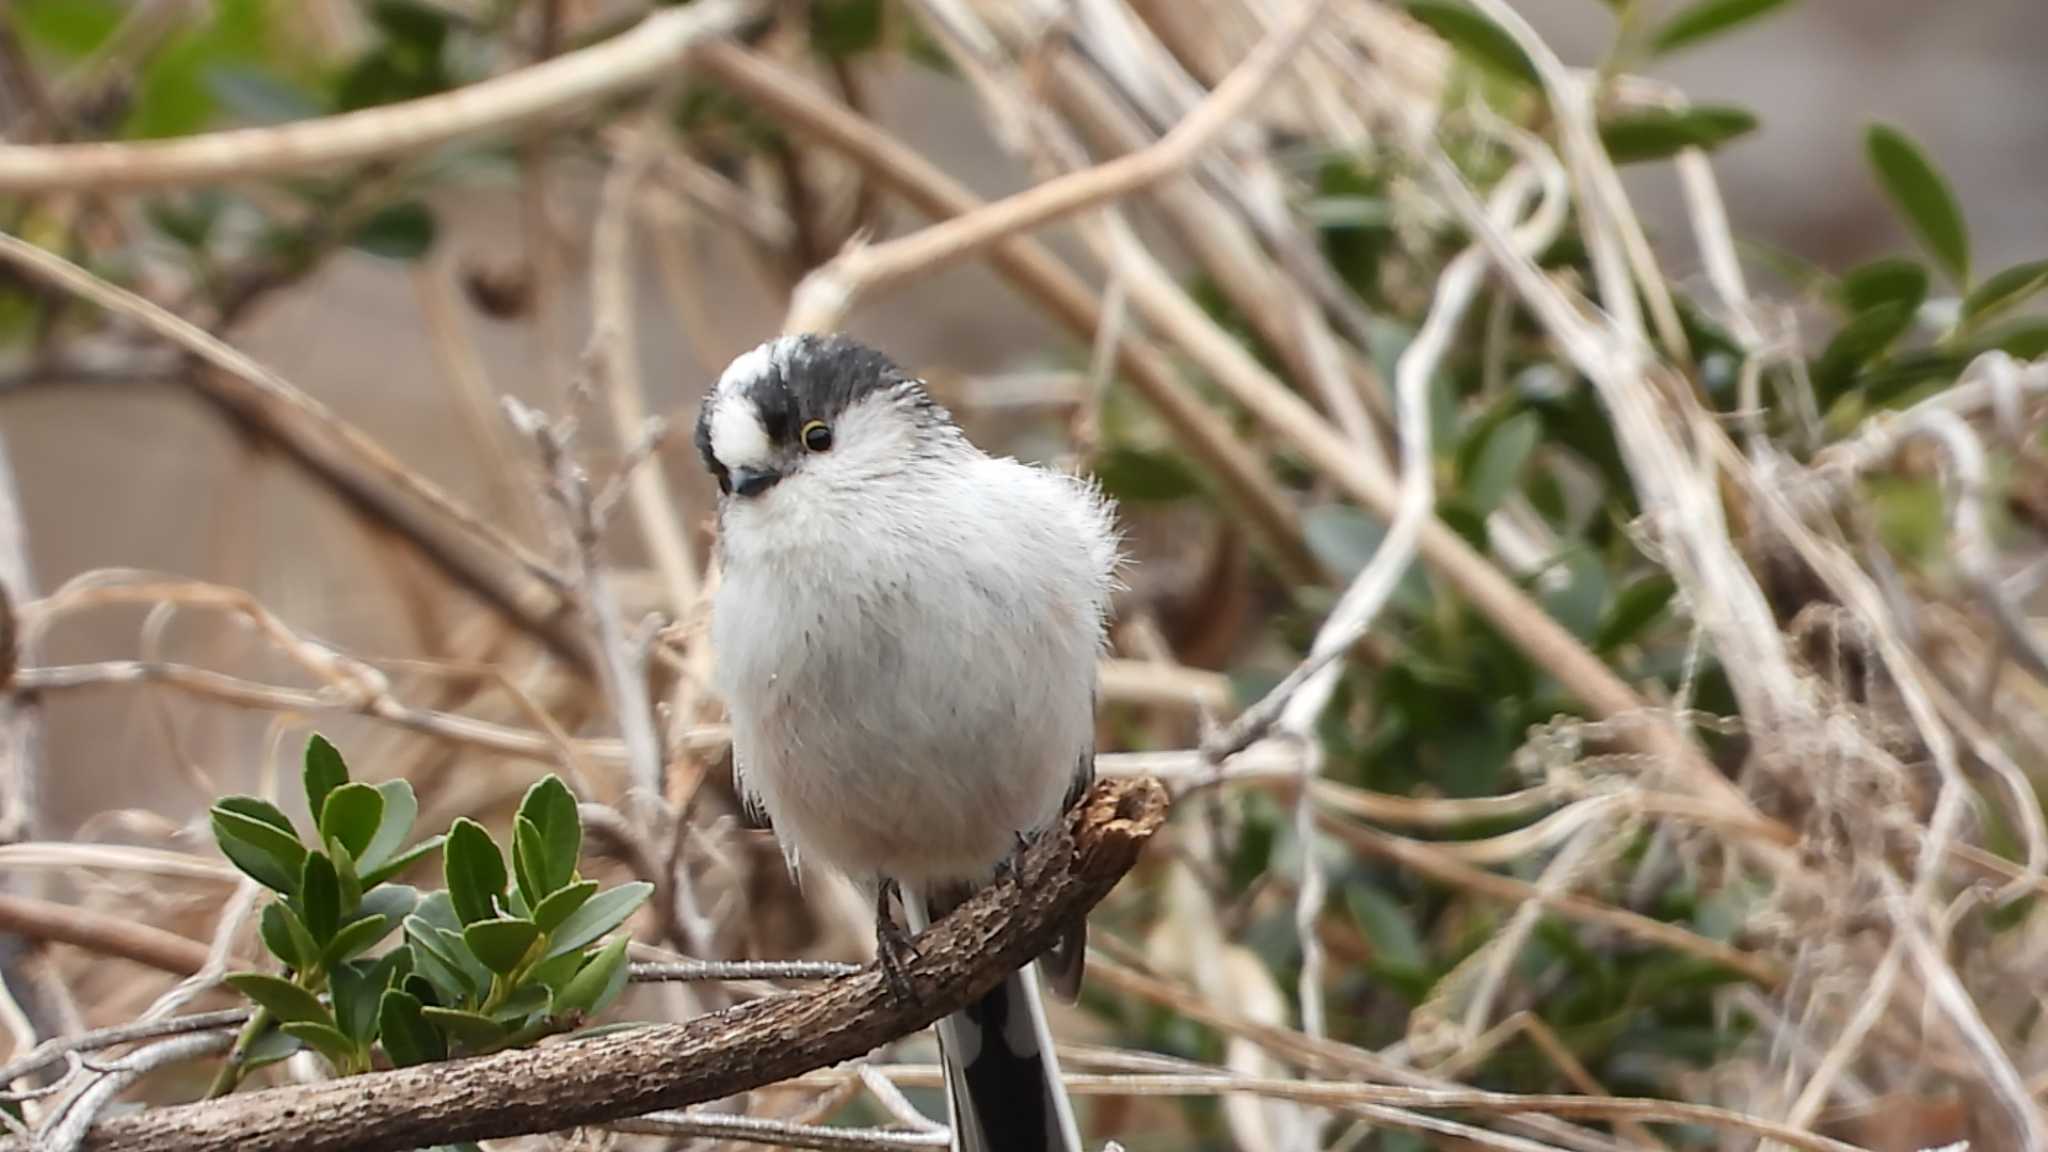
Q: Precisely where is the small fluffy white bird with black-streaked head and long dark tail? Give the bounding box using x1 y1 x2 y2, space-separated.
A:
696 336 1118 1152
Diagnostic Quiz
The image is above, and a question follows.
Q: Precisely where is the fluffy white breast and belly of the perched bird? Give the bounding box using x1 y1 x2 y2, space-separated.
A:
713 432 1116 883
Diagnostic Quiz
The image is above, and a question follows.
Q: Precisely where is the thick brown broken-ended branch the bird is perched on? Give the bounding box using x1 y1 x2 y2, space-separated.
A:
0 779 1167 1152
